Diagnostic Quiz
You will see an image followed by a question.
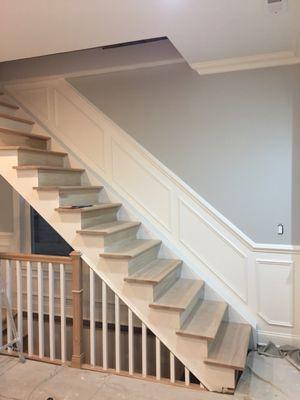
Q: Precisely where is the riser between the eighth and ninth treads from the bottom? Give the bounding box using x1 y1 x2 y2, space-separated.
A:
38 170 82 186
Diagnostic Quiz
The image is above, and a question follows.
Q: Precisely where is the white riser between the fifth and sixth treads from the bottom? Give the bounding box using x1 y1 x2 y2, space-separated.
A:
79 226 139 250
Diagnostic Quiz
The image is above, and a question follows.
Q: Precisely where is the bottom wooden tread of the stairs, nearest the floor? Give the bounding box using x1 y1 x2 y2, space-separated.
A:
204 322 251 371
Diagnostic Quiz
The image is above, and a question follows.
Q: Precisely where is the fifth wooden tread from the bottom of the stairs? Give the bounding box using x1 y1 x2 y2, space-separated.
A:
100 239 161 259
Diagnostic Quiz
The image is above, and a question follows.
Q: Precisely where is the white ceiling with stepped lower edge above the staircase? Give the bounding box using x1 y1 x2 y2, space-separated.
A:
0 0 300 74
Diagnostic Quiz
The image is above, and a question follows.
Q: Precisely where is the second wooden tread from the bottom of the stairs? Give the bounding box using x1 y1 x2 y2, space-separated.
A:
177 300 227 340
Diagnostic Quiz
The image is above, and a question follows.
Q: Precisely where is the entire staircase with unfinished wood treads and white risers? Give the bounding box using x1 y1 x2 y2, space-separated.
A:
0 94 251 392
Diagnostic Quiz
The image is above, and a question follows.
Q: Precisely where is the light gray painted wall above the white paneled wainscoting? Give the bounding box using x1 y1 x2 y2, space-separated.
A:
69 64 300 244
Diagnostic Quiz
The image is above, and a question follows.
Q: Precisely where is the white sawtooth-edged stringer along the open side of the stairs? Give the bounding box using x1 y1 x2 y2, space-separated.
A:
0 93 251 392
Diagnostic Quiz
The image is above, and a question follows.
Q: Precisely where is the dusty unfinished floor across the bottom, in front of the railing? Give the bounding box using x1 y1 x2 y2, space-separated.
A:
0 353 300 400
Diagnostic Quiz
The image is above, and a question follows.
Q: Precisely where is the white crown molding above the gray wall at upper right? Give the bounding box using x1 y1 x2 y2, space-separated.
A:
190 51 300 75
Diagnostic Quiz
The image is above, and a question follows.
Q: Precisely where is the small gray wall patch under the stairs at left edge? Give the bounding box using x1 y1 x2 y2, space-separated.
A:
0 176 13 232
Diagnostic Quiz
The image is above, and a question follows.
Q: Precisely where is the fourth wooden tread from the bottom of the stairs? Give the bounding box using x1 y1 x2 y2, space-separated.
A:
124 258 182 285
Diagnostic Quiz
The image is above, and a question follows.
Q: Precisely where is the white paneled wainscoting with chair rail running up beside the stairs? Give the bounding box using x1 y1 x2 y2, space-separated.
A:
4 78 300 345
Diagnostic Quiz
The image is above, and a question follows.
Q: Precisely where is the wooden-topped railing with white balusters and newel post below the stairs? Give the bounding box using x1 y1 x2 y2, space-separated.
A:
0 252 204 389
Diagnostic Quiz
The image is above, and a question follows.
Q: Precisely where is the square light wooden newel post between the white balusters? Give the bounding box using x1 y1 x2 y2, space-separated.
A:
70 251 84 368
